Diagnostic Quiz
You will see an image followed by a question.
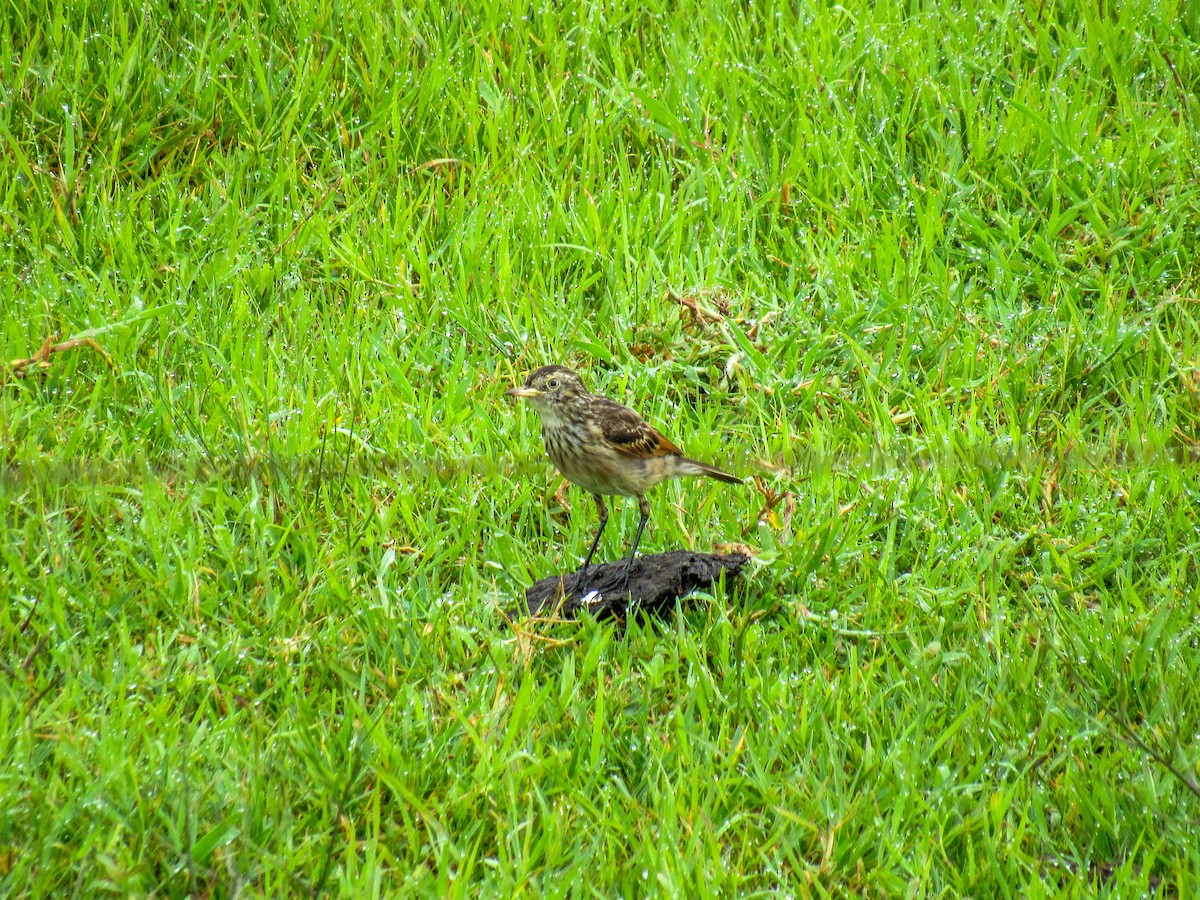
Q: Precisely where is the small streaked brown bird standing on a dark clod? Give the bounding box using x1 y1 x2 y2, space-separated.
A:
504 366 742 582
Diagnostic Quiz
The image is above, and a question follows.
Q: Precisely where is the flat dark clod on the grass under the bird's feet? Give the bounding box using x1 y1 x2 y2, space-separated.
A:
518 550 749 619
